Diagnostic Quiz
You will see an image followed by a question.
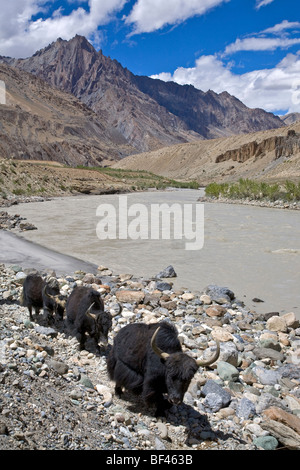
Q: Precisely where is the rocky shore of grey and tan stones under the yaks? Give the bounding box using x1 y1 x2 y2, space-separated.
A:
0 265 300 451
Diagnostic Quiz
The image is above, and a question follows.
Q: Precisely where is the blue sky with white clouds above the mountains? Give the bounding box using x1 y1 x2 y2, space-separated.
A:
0 0 300 114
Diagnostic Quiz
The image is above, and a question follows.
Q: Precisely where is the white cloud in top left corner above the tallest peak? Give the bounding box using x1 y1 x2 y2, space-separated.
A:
0 0 127 57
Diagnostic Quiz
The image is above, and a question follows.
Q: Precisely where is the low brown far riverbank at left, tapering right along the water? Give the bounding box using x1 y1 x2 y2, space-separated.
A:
0 159 198 207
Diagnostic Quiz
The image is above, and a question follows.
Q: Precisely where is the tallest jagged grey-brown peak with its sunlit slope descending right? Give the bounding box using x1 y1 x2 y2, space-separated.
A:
2 36 199 155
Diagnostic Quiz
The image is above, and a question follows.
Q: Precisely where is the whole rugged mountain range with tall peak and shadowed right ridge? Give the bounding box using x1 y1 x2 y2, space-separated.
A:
0 35 283 155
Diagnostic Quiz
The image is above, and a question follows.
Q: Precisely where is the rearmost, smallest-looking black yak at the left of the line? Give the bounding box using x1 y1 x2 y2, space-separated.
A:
20 273 66 321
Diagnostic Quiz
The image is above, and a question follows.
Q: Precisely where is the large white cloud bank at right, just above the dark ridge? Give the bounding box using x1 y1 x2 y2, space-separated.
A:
152 51 300 112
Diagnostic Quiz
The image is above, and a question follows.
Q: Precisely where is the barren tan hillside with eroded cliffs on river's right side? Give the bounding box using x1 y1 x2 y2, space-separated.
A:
114 122 300 185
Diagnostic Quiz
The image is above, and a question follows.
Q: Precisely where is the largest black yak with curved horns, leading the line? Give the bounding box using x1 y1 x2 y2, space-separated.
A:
107 321 220 416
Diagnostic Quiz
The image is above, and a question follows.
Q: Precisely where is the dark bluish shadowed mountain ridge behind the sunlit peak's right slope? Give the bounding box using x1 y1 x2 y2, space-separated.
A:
134 76 282 139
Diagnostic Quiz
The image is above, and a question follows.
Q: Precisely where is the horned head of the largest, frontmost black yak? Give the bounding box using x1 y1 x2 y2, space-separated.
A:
151 328 220 405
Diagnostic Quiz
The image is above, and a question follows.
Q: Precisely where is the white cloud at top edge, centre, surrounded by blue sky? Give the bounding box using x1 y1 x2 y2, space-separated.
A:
126 0 230 34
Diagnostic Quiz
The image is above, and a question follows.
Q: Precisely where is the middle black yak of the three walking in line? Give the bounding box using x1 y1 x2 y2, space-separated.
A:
66 286 112 351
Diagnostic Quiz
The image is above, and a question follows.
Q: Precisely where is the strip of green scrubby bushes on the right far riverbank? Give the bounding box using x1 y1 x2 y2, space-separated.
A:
205 178 300 202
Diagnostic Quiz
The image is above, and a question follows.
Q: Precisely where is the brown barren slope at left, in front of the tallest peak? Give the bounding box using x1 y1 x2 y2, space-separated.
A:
0 64 134 166
